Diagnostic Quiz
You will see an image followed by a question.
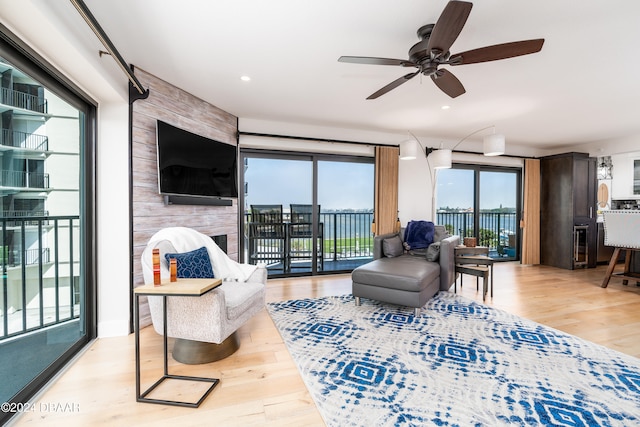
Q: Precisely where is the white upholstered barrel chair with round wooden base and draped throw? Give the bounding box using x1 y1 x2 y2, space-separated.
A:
141 227 267 364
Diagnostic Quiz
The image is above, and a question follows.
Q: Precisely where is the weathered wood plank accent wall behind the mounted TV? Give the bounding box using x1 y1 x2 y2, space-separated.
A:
131 68 238 324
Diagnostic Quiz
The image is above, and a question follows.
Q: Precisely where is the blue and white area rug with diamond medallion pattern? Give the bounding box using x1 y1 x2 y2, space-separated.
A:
268 292 640 427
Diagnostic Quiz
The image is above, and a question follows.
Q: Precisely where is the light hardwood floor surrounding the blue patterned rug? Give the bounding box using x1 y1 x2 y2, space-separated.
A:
14 263 640 427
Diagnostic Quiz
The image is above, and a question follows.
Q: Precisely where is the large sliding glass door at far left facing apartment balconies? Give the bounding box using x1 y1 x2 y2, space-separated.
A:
0 35 95 424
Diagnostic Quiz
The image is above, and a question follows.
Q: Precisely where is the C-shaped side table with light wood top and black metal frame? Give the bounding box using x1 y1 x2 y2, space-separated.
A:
133 279 222 408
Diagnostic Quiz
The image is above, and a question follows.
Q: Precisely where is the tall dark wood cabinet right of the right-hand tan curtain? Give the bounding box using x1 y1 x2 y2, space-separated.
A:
540 153 598 270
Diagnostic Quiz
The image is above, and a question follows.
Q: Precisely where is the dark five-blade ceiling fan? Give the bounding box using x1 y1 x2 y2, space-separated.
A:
338 0 544 99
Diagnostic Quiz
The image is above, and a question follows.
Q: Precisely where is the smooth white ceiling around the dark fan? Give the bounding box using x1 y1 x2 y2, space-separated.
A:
46 0 640 153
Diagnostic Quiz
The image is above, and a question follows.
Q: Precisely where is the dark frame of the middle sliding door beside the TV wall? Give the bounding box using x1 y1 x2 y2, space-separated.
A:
238 148 374 278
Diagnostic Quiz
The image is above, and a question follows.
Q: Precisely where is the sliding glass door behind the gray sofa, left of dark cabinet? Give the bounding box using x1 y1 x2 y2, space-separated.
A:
436 165 521 260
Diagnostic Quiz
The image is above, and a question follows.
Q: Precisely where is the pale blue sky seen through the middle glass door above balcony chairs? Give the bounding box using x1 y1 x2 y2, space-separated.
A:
245 158 374 211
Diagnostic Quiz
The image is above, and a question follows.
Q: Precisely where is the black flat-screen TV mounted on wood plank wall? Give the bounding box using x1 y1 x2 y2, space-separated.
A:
156 120 238 197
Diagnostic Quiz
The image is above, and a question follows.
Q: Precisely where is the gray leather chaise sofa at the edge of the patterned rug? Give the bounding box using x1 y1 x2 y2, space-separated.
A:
351 225 460 316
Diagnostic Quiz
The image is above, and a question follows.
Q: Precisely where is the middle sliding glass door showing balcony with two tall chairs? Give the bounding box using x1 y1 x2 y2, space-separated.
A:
241 150 374 277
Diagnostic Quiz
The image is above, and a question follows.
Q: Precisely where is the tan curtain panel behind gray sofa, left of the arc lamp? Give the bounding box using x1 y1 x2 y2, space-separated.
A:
373 147 400 235
